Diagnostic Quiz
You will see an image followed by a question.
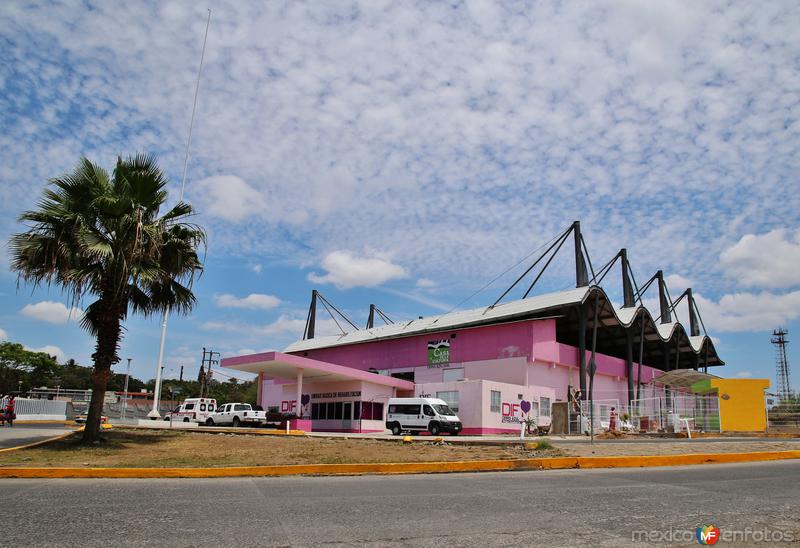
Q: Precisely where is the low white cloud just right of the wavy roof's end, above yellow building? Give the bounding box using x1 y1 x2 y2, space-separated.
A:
682 290 800 331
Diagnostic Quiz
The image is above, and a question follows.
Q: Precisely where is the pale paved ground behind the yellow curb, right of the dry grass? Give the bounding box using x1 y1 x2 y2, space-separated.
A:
551 439 800 457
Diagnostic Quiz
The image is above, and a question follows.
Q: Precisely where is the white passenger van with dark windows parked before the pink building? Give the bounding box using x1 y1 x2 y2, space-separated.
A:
386 398 462 436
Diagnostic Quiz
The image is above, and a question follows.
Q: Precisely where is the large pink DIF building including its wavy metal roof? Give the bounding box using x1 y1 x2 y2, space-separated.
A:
222 285 723 434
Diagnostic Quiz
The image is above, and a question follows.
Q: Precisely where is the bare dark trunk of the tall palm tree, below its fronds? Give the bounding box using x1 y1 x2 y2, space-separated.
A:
82 306 120 443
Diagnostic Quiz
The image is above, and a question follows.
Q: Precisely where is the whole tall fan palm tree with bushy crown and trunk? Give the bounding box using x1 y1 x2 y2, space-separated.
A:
9 155 205 443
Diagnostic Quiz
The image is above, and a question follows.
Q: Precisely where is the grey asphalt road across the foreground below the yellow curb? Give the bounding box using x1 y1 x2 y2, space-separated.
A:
0 461 800 547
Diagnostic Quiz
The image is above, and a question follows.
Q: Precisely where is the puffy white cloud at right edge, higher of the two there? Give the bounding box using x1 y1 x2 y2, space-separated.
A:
720 228 800 288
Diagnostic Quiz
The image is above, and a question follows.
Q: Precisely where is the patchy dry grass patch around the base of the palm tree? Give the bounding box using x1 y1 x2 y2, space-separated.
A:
0 428 560 467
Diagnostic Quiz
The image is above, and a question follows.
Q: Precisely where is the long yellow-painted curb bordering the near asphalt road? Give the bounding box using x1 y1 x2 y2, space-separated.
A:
0 450 800 478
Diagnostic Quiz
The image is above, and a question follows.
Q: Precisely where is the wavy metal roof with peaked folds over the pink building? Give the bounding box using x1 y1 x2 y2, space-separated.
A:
284 286 725 369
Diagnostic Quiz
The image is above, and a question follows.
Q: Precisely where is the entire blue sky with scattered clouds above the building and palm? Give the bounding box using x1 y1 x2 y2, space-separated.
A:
0 0 800 388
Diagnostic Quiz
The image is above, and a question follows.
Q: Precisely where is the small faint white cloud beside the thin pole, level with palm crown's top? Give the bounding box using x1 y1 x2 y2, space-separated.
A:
192 175 266 223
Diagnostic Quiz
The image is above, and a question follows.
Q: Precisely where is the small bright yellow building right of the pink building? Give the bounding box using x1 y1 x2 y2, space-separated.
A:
692 378 769 432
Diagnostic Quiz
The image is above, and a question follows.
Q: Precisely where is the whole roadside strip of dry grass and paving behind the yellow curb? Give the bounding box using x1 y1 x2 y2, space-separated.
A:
0 428 800 467
